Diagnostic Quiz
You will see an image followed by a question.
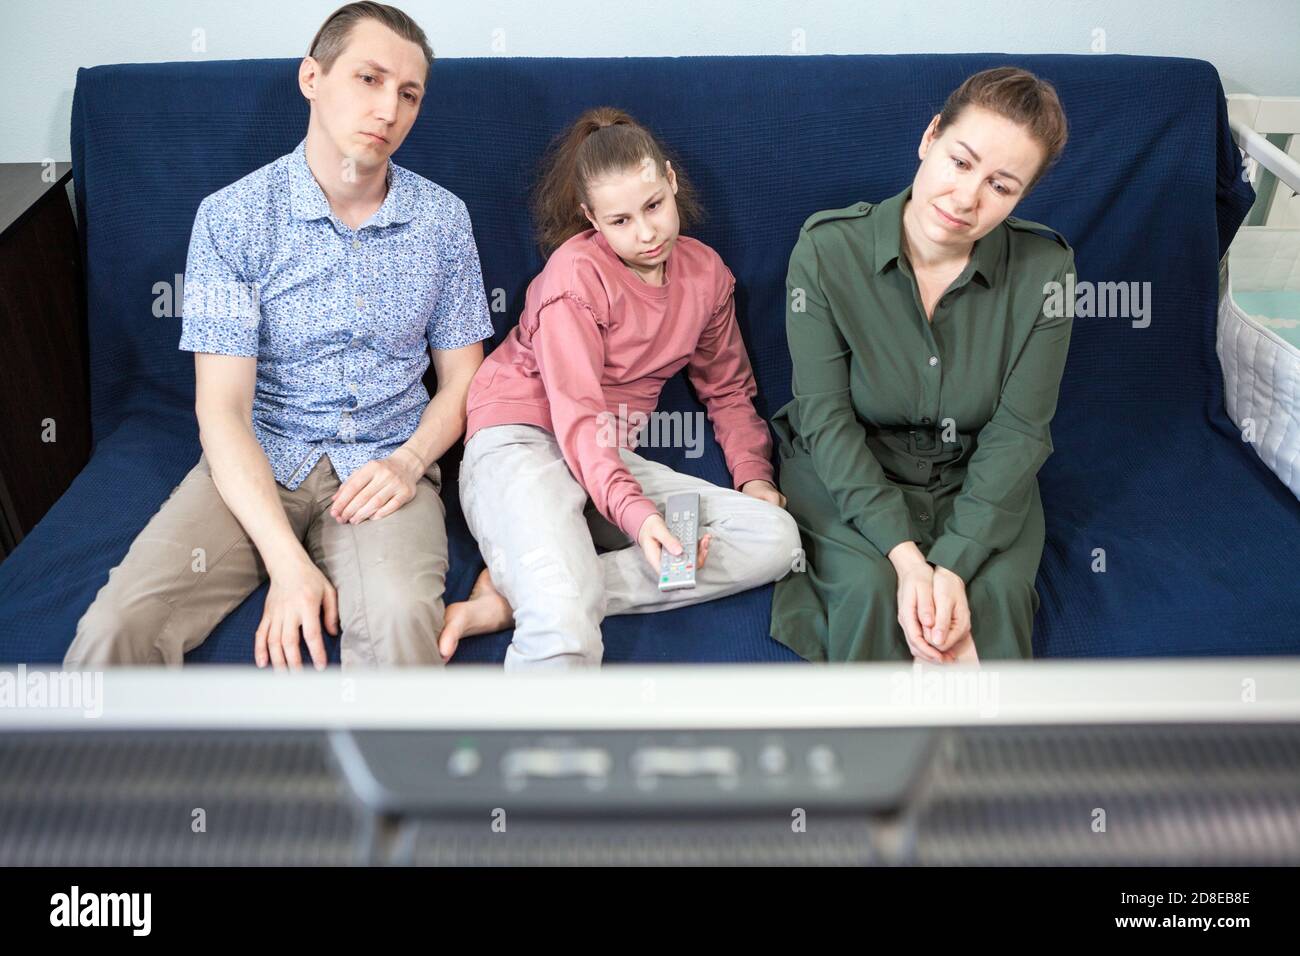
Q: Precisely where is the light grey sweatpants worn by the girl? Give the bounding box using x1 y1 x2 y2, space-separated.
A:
460 425 800 670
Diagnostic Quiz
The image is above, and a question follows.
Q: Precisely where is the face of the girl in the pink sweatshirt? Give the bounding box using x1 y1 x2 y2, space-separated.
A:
582 159 681 276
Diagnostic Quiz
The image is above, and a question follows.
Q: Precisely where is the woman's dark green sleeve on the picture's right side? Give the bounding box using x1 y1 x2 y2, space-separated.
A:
926 251 1074 581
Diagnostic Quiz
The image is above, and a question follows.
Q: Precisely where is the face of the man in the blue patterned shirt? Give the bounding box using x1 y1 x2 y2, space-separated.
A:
298 20 428 170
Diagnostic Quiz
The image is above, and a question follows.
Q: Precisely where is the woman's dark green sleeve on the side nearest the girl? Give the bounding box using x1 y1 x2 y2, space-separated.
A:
785 229 919 555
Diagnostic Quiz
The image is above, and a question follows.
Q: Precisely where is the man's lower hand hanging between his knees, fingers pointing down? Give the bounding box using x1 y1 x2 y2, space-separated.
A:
254 554 338 670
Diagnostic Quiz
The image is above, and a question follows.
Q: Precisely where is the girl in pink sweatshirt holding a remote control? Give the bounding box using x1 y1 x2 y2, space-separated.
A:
438 107 800 670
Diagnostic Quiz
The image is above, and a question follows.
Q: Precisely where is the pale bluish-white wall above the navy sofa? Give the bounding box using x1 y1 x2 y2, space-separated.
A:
0 0 1300 163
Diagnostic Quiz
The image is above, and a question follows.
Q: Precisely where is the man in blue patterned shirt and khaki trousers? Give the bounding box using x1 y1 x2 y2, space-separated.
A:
65 3 493 670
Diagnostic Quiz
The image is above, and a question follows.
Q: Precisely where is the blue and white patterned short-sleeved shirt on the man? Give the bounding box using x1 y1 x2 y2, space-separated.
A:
181 139 493 489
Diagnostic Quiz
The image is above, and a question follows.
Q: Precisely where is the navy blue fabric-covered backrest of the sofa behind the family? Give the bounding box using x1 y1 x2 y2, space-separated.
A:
73 55 1253 463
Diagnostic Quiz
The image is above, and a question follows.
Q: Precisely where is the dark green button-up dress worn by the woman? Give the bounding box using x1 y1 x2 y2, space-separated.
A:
771 186 1074 661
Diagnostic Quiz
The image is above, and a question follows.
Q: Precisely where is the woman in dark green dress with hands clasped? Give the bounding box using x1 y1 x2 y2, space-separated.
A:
771 68 1074 663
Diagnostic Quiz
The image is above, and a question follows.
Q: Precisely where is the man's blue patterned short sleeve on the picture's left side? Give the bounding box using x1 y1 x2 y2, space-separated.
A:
181 196 261 355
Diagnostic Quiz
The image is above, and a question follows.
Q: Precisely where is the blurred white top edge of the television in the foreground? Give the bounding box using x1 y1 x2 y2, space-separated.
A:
0 657 1300 732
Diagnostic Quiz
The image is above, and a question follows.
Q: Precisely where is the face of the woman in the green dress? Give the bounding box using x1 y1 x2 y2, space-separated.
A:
911 107 1045 247
